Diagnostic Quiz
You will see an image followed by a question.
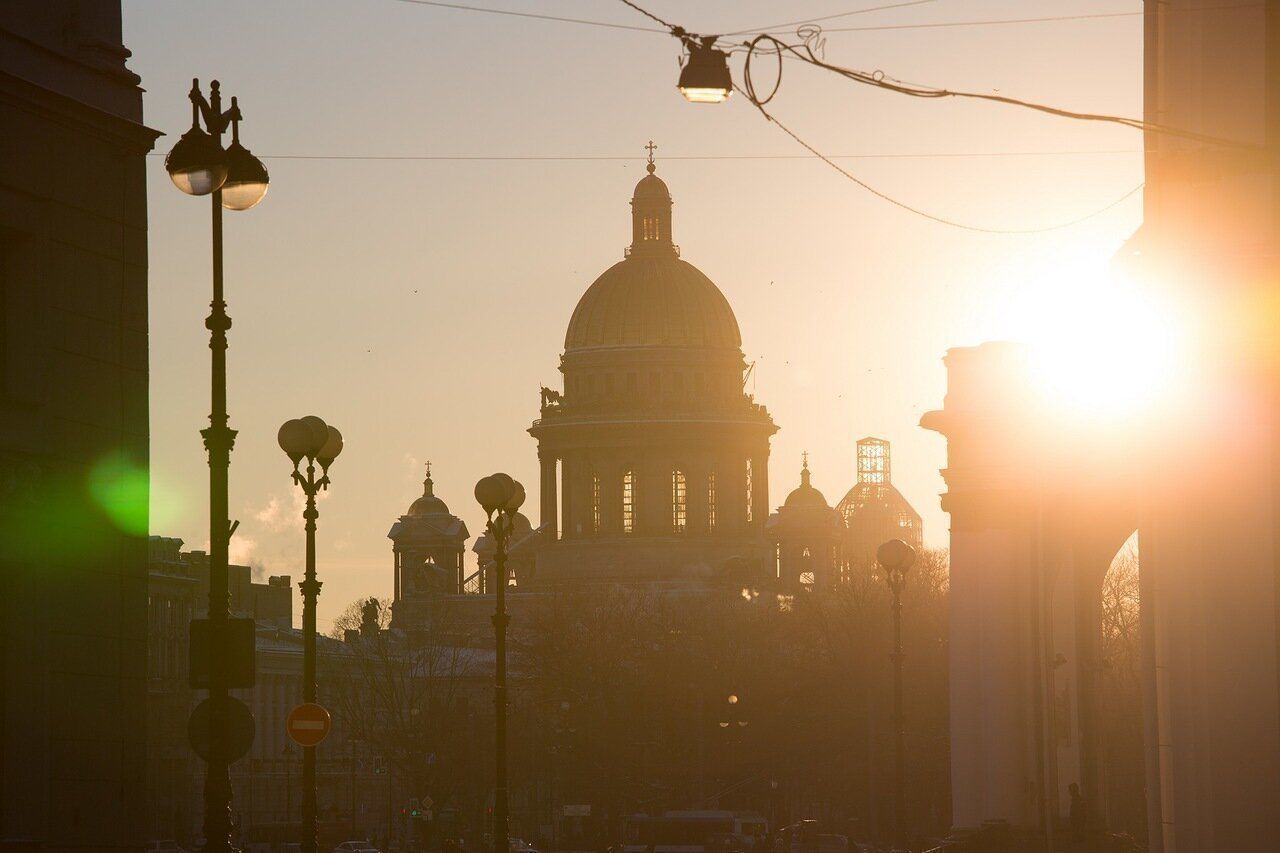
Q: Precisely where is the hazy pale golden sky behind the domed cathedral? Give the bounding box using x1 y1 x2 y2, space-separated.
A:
124 0 1142 629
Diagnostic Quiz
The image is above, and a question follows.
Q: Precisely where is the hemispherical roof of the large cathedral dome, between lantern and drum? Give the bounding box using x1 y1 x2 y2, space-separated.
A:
564 258 742 351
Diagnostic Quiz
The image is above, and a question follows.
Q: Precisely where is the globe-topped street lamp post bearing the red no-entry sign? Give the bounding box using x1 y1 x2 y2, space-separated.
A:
278 415 342 853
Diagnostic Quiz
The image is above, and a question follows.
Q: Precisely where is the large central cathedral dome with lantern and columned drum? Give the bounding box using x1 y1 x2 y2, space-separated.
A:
529 151 777 584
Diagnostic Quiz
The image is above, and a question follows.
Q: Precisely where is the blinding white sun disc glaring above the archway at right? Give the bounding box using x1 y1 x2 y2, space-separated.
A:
1011 254 1179 420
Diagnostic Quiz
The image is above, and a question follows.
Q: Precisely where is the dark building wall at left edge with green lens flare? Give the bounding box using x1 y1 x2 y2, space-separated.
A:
0 0 157 850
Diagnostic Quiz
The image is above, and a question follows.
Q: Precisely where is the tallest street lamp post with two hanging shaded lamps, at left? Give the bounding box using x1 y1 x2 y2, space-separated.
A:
165 79 269 853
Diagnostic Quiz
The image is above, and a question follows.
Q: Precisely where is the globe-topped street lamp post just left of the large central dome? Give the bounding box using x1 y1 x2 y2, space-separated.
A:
475 474 525 853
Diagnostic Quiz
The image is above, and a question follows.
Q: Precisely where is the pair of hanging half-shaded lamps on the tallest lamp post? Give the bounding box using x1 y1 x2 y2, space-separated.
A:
164 112 270 210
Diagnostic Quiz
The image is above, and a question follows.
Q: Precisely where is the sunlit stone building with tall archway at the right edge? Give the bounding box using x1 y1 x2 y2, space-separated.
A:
923 0 1280 853
